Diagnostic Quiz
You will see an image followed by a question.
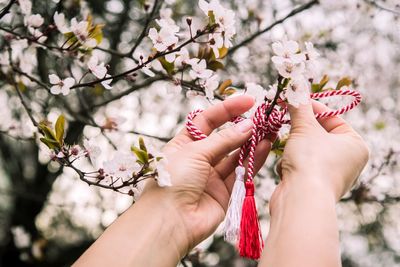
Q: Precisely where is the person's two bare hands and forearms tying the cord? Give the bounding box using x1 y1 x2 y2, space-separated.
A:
74 96 368 266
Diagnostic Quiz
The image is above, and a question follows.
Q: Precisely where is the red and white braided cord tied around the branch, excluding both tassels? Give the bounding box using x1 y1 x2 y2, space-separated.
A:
186 90 361 181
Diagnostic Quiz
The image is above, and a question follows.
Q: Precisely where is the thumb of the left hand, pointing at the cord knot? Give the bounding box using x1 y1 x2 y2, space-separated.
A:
194 119 253 165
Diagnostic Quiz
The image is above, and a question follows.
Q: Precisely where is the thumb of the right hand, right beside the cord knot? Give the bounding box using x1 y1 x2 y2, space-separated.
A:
288 101 318 132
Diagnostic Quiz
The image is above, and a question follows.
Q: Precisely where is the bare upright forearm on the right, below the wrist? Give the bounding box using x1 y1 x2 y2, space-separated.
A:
260 177 341 267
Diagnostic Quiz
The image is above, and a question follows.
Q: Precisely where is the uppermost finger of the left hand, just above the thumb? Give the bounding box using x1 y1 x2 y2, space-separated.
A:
173 95 255 142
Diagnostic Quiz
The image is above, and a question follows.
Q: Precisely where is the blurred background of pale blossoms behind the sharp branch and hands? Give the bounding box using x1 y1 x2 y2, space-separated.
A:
0 0 400 267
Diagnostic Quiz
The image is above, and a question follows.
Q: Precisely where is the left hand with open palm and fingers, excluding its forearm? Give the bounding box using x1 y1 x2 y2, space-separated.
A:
139 95 271 256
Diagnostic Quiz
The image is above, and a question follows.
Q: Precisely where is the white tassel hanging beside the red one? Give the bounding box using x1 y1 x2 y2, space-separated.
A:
224 166 246 243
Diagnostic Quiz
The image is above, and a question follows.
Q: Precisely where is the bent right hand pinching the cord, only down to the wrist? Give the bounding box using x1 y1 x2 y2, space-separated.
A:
272 101 369 206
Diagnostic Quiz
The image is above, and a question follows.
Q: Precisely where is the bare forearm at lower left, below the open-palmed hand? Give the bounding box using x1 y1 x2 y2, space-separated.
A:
74 191 187 267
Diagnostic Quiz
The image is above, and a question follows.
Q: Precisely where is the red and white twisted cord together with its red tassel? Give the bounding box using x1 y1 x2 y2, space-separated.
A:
186 90 361 259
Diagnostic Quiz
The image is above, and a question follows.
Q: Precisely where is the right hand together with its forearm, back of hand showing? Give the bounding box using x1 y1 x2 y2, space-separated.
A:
259 101 368 267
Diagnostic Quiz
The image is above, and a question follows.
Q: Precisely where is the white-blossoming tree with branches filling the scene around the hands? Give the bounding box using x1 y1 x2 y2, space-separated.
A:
0 0 400 266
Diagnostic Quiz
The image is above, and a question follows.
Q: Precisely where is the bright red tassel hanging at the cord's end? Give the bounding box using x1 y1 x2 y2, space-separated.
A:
239 181 264 260
